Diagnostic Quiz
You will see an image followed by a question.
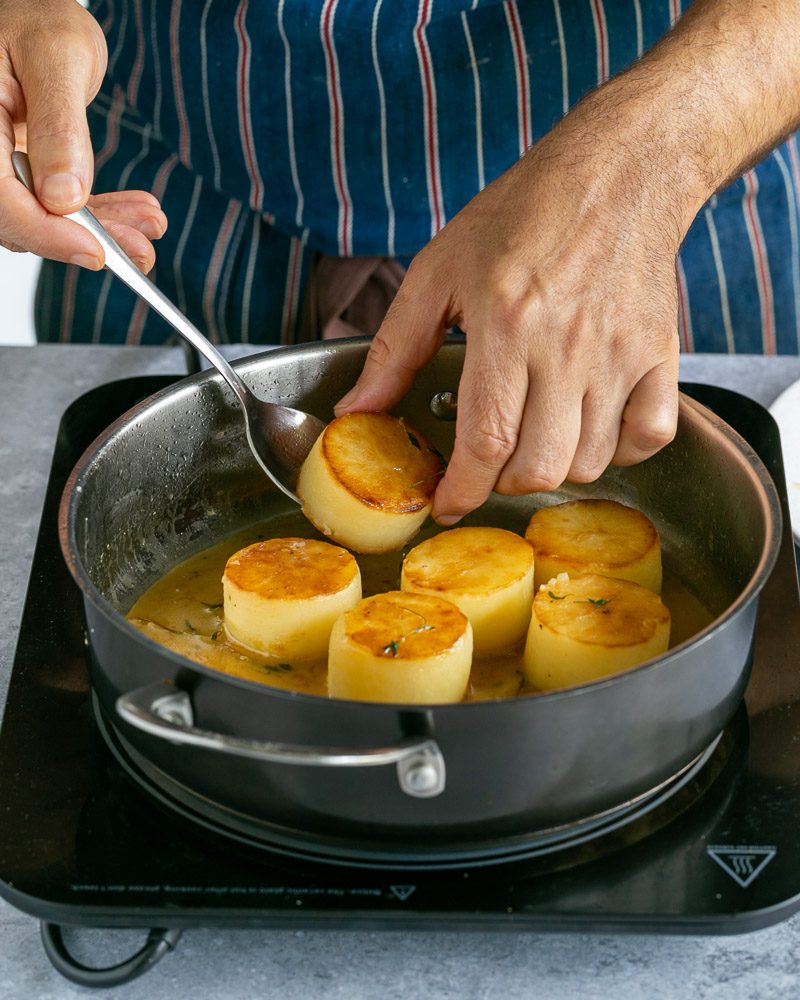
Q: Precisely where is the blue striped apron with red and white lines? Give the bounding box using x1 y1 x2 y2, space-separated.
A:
37 0 800 353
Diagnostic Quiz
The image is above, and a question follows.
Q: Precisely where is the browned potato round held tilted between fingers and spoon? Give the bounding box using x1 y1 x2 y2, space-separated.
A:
297 413 444 553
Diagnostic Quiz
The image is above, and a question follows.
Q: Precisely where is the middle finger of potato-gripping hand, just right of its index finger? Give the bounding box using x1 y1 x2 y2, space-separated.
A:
495 369 583 496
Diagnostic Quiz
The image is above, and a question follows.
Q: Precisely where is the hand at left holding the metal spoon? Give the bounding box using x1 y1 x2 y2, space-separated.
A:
0 0 167 272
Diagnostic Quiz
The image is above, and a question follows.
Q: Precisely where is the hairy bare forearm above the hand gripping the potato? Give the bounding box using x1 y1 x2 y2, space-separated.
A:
556 0 800 243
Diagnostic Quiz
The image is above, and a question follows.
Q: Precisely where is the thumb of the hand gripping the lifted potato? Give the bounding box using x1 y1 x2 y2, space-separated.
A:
334 264 447 416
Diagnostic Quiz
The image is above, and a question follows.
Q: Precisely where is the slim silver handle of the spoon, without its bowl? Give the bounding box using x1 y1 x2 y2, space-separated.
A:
11 150 250 406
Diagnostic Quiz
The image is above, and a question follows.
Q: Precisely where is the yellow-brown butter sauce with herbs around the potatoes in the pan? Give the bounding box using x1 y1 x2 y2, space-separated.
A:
127 511 712 701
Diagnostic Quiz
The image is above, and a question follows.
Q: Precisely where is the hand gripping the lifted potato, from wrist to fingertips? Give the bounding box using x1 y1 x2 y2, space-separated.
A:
336 89 689 524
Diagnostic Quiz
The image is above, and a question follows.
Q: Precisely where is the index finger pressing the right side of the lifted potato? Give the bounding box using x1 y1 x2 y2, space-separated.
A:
432 336 528 525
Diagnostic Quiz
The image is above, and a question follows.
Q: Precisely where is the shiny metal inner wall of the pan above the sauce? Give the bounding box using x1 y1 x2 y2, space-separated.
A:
66 343 769 640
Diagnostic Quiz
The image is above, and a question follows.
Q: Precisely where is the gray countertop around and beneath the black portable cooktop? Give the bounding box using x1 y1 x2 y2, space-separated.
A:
0 346 800 1000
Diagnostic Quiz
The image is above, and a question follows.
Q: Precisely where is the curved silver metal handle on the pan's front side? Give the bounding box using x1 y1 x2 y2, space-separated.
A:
116 682 445 799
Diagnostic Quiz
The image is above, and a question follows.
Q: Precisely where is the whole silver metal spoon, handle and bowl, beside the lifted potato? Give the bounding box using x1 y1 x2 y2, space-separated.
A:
11 151 325 504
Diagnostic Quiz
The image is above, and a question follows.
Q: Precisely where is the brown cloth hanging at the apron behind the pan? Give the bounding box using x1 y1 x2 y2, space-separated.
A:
298 254 405 342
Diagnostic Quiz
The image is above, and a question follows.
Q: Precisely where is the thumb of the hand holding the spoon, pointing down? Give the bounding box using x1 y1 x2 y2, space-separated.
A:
17 25 105 215
